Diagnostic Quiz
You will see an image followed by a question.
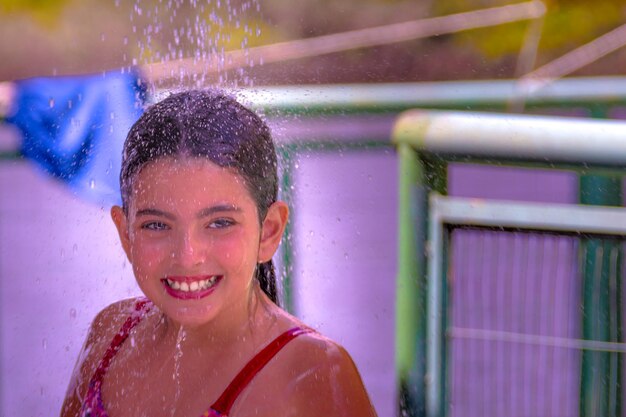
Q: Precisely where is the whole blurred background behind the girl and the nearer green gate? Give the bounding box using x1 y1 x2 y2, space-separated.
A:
0 0 626 417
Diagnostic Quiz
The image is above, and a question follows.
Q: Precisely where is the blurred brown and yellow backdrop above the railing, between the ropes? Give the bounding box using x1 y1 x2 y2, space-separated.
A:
0 0 626 84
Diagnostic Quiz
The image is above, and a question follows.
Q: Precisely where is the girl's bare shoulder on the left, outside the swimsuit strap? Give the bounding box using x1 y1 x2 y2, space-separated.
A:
61 298 144 417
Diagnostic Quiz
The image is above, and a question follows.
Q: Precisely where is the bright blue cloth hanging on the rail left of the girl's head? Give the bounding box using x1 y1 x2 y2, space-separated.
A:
5 71 146 206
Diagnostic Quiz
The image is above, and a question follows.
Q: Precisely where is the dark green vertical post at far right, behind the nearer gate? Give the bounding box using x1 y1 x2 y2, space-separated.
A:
579 107 622 417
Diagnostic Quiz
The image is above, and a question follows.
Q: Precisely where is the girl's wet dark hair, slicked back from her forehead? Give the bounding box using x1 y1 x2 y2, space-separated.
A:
120 90 278 304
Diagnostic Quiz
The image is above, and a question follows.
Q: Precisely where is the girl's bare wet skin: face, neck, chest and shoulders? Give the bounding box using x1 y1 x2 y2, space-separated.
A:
61 158 375 417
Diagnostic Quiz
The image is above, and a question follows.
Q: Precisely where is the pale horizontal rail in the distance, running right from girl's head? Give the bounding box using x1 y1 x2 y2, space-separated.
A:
234 77 626 115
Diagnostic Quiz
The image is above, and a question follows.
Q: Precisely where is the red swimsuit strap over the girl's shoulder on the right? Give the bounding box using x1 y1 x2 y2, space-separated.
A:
211 327 313 416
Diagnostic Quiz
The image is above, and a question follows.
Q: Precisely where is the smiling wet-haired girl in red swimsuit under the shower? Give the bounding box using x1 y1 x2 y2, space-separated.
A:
61 91 375 417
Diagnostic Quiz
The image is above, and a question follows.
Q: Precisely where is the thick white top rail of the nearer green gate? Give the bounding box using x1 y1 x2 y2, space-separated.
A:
393 110 626 167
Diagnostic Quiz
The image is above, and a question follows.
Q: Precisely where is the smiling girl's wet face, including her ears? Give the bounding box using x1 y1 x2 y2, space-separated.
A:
112 158 287 326
